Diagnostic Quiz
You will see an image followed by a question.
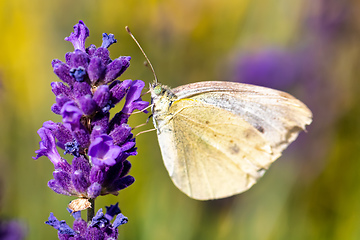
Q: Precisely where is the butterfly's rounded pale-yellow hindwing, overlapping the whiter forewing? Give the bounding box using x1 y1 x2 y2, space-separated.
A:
158 99 273 200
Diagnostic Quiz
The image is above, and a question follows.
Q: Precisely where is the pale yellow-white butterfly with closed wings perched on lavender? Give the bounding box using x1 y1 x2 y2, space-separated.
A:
150 82 312 200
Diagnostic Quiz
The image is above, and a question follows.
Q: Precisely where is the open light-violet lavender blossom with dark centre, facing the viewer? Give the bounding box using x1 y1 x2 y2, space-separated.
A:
89 134 121 166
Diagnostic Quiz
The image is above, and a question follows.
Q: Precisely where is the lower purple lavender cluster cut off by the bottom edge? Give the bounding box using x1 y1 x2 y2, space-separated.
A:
45 203 128 240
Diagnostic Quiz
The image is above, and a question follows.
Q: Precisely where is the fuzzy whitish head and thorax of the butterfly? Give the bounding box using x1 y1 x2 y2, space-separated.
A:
150 83 177 128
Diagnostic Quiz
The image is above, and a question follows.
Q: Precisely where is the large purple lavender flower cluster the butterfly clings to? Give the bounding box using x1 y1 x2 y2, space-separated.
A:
34 21 149 199
